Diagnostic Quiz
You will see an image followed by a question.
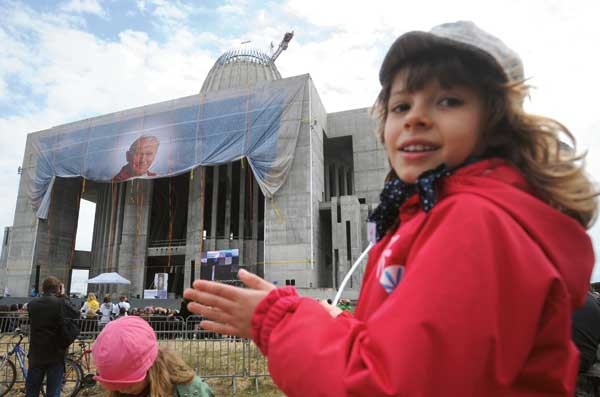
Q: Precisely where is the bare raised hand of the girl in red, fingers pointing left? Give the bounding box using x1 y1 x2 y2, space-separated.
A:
183 270 275 338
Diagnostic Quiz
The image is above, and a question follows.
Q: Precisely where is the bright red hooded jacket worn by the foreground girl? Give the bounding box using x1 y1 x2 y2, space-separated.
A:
252 159 594 397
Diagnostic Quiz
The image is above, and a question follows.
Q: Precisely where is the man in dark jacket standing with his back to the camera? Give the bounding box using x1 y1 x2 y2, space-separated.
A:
25 276 79 397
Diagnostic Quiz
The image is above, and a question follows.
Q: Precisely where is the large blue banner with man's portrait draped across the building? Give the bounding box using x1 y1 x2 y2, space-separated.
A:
25 75 309 219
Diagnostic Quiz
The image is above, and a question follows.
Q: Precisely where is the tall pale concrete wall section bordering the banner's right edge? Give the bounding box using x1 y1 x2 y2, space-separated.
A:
264 79 325 287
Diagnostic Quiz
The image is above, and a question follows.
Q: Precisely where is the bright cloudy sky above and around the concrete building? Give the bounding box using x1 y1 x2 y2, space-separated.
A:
0 0 600 281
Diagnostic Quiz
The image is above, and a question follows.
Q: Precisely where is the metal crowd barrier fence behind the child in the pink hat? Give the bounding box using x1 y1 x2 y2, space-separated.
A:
0 313 270 394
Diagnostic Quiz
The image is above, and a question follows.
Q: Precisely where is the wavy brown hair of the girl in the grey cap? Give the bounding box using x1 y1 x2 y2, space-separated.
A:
372 48 598 228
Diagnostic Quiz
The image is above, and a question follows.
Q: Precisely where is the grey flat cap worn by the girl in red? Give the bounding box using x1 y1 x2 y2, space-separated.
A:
379 21 524 84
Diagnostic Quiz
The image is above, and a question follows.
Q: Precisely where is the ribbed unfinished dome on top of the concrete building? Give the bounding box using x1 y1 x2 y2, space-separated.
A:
200 48 281 94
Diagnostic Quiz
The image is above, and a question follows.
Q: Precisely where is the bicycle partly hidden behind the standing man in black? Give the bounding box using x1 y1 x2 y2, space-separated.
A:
0 329 81 397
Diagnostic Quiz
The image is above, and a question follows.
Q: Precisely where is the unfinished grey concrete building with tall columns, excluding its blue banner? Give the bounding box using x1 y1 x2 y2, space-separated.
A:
0 49 388 297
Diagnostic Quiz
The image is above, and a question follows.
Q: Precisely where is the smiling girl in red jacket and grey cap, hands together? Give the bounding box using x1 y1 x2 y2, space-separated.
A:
184 22 596 397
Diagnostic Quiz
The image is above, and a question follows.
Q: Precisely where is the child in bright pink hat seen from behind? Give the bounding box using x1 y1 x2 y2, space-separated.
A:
92 316 213 397
